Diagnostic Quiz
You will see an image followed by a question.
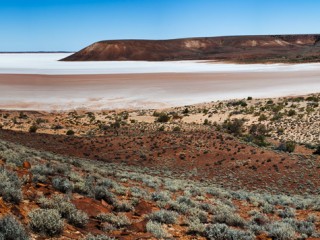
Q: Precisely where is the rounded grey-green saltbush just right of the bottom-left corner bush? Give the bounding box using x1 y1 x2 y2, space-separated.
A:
29 209 64 237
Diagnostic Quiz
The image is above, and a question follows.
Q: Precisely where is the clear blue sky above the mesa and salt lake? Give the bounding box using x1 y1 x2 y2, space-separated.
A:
0 0 320 51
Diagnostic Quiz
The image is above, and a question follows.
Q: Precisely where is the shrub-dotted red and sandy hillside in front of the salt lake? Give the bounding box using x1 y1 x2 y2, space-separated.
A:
0 94 320 240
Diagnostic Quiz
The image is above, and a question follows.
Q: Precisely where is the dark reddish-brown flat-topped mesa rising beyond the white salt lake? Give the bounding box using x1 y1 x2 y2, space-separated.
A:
62 34 320 63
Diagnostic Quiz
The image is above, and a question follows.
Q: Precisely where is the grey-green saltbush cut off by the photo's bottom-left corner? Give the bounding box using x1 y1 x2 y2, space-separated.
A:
0 215 29 240
